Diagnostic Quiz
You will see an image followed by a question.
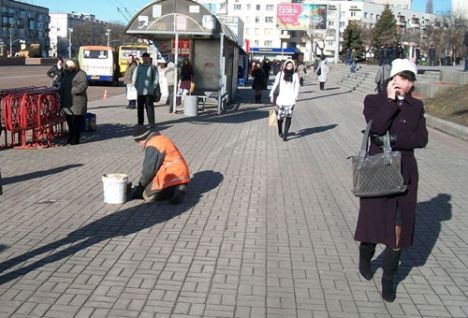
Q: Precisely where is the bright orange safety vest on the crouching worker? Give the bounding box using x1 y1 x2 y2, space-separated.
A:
146 135 190 190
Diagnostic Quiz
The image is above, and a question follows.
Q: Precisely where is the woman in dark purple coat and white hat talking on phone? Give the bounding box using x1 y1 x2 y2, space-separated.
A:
354 59 428 302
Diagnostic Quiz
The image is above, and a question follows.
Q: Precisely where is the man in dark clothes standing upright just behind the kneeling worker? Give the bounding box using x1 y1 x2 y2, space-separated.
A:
132 52 159 126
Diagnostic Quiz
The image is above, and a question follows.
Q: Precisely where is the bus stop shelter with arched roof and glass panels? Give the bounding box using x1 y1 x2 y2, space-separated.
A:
126 0 239 114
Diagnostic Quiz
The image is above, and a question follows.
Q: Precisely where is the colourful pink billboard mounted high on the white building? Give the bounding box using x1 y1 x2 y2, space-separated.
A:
276 3 327 31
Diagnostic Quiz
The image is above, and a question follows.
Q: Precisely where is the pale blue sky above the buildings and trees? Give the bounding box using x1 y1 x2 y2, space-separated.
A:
27 0 452 24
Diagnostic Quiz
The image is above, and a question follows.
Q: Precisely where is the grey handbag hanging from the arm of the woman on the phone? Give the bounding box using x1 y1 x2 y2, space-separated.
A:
351 120 406 197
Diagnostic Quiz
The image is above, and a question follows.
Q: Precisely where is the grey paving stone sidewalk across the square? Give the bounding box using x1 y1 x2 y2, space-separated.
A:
0 75 468 318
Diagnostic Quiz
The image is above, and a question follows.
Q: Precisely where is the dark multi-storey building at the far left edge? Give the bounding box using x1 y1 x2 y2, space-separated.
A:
0 0 50 56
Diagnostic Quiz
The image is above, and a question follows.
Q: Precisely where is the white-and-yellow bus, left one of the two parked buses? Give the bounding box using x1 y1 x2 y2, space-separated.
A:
78 45 119 85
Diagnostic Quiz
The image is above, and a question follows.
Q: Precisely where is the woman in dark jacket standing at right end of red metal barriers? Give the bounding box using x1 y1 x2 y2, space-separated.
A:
60 60 88 145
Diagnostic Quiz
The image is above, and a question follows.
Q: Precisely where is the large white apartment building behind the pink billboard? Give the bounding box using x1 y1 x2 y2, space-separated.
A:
198 0 442 61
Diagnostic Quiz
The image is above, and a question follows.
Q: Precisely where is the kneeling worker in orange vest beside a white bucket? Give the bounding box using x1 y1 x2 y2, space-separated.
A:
130 126 190 204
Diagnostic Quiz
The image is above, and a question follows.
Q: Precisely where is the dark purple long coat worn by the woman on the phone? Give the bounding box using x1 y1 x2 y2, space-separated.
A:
354 91 428 248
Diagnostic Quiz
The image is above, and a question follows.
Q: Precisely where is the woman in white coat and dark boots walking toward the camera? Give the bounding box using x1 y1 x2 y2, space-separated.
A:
270 60 300 141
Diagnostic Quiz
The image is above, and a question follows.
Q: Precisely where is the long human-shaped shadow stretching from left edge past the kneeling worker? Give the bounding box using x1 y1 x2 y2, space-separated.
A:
0 171 223 285
